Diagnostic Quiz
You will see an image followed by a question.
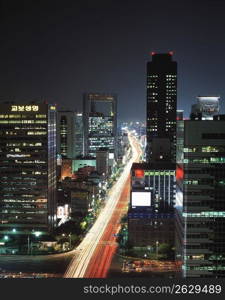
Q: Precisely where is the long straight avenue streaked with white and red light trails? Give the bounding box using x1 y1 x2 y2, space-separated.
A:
64 134 142 278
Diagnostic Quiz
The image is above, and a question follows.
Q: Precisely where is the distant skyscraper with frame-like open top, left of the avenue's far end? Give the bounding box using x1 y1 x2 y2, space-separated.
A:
83 93 117 159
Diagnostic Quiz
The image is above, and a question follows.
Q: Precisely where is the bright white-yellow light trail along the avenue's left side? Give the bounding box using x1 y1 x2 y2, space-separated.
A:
63 132 141 278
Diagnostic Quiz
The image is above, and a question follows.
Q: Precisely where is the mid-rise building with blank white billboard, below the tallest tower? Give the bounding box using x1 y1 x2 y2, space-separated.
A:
128 163 176 247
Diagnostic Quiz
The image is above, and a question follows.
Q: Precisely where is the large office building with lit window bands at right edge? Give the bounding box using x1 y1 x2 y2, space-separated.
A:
176 105 225 278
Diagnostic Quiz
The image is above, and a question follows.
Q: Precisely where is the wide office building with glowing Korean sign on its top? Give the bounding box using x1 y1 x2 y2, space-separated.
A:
0 102 56 234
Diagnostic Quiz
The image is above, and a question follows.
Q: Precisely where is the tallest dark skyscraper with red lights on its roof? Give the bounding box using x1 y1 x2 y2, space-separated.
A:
146 52 177 162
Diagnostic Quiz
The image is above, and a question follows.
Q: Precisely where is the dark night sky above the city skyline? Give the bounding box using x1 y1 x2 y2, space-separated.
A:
0 0 225 120
